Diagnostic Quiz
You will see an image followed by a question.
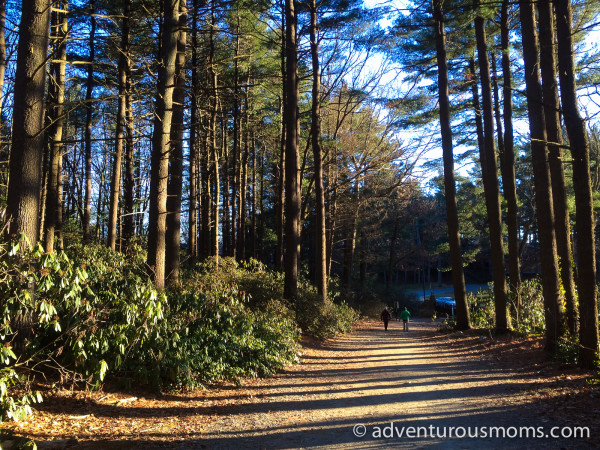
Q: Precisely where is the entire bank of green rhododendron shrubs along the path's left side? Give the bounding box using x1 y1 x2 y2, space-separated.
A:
0 242 357 420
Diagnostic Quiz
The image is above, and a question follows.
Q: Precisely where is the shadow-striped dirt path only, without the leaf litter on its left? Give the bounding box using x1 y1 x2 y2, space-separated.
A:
186 321 586 448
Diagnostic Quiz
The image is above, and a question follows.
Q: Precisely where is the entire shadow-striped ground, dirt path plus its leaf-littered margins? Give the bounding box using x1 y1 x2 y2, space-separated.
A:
2 320 600 449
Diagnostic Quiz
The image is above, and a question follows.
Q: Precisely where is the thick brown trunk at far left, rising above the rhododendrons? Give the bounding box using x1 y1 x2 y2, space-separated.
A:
6 0 50 245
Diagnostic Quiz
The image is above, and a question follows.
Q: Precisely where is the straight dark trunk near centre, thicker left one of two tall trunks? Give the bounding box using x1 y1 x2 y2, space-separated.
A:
284 0 300 300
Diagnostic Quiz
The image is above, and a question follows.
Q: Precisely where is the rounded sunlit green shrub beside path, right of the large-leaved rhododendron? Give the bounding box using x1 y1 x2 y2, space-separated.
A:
161 286 299 387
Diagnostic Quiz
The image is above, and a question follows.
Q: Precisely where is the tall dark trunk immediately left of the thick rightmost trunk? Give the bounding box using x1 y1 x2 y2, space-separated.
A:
538 0 579 336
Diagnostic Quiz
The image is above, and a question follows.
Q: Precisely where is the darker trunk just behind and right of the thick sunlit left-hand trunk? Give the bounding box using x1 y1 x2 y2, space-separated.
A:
165 1 187 285
